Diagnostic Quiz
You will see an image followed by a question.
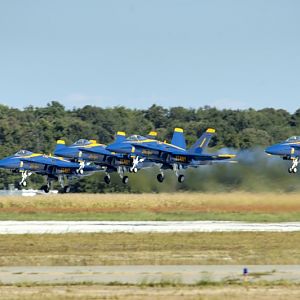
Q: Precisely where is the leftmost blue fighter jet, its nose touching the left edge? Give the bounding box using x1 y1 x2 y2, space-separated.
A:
0 150 98 193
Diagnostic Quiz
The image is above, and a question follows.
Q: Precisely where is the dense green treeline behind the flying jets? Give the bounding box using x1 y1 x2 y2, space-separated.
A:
0 101 300 192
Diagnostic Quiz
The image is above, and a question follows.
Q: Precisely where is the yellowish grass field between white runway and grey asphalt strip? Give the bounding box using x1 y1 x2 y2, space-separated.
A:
0 232 300 266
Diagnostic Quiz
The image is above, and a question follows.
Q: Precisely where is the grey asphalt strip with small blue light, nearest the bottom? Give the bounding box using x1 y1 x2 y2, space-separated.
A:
0 265 300 284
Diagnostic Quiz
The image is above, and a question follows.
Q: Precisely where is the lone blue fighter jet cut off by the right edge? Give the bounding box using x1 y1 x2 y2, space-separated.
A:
265 136 300 173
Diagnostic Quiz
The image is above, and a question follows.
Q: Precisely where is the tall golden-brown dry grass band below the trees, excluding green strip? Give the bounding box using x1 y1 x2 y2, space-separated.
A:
0 192 300 212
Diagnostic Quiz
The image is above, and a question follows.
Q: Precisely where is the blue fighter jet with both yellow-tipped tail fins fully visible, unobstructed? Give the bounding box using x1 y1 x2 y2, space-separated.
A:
106 128 235 183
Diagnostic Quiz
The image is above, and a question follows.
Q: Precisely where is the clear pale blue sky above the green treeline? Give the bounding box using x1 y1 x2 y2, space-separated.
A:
0 0 300 112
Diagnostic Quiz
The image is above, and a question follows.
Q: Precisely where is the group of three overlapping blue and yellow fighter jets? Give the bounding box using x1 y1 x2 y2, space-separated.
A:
0 128 235 193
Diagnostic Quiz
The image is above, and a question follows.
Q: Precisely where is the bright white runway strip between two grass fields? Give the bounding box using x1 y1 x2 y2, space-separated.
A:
0 221 300 234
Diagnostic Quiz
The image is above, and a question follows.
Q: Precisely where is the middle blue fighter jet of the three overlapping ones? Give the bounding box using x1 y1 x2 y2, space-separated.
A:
54 131 156 184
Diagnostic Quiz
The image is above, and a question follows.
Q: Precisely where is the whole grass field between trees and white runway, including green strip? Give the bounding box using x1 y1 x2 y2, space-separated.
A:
0 192 300 222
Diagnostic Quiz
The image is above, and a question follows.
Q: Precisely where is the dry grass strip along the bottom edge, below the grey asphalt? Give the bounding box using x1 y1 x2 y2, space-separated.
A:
0 286 300 300
